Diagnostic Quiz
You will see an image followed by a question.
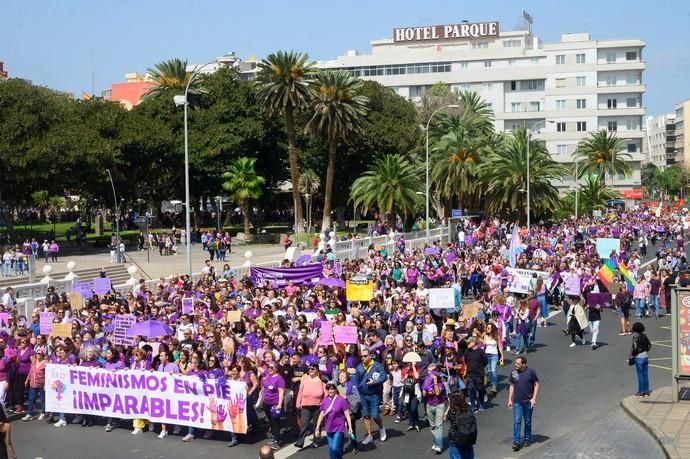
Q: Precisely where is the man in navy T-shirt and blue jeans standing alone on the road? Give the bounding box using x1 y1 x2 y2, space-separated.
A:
508 356 539 451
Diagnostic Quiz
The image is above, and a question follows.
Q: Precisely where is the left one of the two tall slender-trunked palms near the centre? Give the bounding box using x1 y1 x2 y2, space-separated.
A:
256 51 317 230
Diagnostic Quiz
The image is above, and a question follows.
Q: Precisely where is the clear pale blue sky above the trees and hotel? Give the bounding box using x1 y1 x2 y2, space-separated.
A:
0 0 690 115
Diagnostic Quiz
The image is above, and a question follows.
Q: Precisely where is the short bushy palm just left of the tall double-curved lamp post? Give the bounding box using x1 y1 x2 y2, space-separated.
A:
350 154 421 227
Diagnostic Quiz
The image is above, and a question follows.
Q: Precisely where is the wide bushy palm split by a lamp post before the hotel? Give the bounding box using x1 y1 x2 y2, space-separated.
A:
479 129 568 222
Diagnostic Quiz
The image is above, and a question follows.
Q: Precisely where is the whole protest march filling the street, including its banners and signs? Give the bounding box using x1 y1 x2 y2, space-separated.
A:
0 208 688 454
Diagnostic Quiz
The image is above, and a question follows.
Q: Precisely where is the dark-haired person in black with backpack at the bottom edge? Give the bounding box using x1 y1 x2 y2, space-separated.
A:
443 390 477 459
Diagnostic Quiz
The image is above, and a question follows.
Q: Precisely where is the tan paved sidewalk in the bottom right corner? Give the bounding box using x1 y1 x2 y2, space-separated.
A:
621 386 690 459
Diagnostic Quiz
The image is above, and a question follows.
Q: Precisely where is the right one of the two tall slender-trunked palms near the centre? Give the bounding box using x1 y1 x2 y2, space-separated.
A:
304 71 369 230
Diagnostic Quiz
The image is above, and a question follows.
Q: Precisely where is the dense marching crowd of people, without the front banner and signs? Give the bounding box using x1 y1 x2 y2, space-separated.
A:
0 209 687 459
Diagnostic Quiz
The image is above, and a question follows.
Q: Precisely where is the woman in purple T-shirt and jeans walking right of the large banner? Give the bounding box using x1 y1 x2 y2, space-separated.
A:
314 382 352 459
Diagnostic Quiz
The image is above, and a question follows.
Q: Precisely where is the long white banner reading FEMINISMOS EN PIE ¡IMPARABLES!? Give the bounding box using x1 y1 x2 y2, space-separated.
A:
45 364 247 433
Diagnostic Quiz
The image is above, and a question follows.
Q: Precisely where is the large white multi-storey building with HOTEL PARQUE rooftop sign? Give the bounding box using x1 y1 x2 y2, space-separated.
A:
319 22 645 190
